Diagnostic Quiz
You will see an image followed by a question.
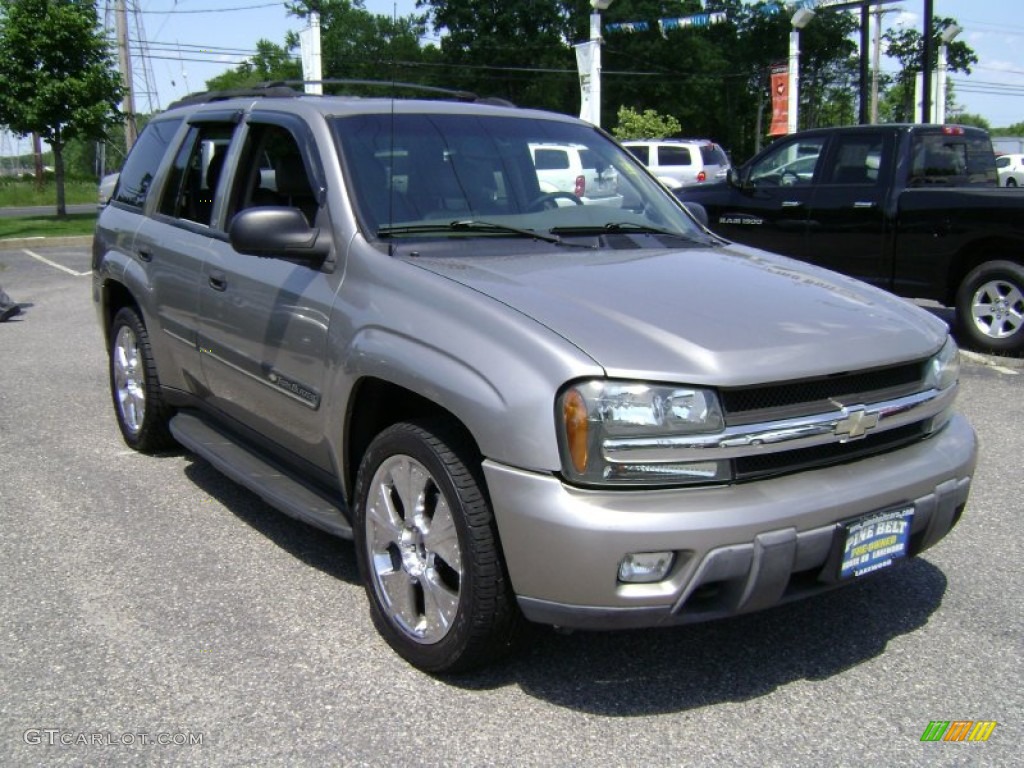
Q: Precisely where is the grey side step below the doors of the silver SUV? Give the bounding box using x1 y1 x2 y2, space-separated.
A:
170 412 352 539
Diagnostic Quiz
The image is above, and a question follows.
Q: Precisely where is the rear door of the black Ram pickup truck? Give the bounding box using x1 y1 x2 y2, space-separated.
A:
804 131 896 288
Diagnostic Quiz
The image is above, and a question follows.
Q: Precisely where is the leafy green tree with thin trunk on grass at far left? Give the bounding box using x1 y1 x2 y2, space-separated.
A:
0 0 122 216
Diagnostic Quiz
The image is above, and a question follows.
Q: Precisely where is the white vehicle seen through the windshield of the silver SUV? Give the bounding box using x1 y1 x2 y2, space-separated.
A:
529 143 623 208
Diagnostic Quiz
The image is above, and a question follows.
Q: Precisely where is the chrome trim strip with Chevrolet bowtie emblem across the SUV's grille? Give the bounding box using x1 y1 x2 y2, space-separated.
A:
602 386 957 464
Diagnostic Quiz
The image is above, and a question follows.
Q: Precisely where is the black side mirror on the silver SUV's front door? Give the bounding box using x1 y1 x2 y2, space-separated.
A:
227 206 331 263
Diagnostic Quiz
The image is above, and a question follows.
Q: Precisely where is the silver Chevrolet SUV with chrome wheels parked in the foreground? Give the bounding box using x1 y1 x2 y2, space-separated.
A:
92 87 976 672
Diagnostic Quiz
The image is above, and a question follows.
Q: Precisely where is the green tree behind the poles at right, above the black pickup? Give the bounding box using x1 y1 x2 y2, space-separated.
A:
882 17 978 123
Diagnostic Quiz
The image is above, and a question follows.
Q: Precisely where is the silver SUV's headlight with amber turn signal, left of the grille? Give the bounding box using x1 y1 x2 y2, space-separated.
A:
557 380 730 485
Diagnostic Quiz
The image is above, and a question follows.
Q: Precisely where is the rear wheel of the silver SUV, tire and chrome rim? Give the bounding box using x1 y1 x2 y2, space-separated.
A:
111 307 174 454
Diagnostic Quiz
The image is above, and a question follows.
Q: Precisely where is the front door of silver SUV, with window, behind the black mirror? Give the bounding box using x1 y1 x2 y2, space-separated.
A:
200 114 342 468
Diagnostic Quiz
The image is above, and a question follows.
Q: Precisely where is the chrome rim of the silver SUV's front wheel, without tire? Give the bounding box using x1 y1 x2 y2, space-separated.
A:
365 455 463 644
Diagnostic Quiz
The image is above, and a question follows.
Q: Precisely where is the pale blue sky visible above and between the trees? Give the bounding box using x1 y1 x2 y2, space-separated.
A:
2 0 1024 154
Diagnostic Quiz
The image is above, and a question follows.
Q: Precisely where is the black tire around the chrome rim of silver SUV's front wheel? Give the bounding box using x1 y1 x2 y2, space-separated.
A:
353 422 514 673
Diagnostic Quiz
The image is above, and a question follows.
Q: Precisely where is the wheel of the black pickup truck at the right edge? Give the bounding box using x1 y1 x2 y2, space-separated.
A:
956 261 1024 352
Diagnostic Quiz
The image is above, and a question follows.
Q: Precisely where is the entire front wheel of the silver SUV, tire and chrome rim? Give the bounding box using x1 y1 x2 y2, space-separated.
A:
354 422 523 673
